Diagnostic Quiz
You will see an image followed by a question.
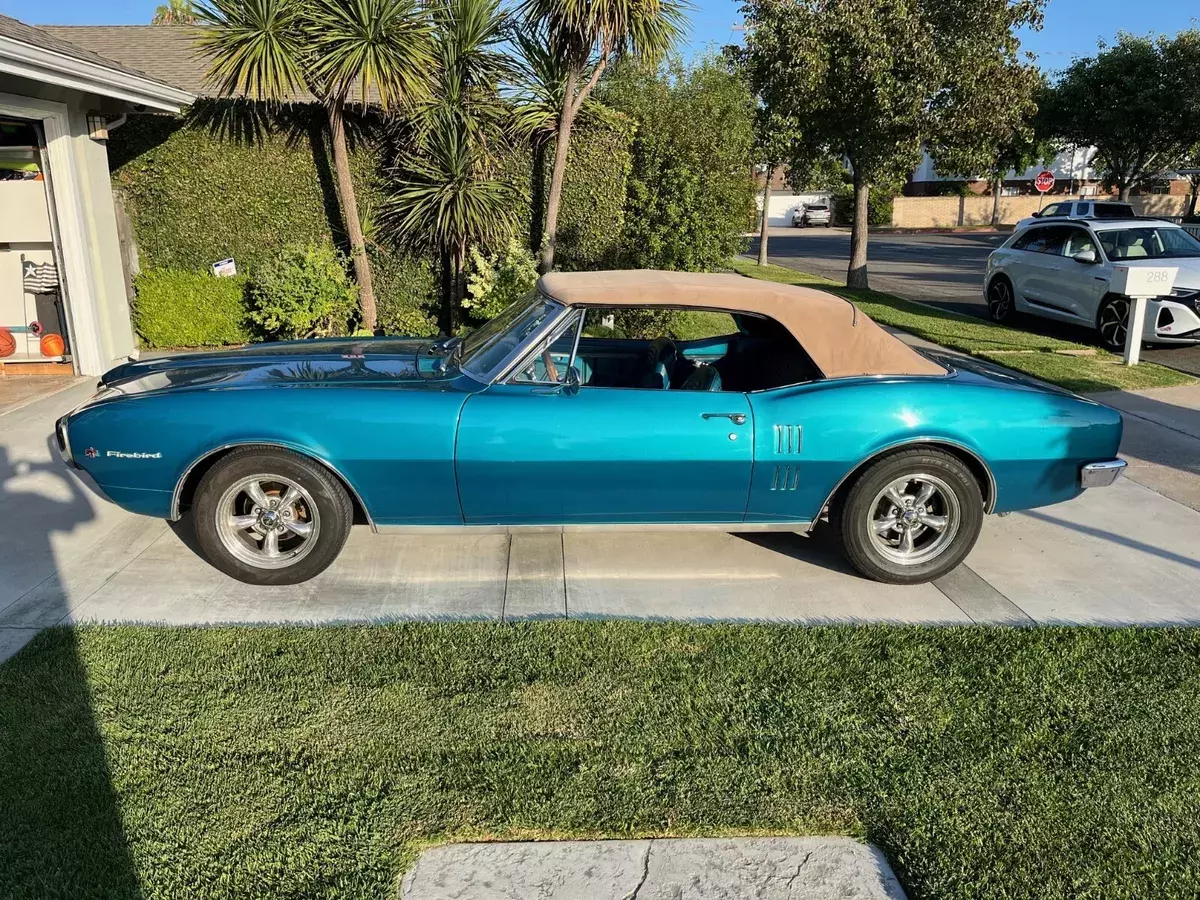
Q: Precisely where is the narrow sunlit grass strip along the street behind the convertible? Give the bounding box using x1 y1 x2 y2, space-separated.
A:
731 257 1195 392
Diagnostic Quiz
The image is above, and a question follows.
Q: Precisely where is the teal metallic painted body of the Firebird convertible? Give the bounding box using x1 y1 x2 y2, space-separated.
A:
58 338 1121 528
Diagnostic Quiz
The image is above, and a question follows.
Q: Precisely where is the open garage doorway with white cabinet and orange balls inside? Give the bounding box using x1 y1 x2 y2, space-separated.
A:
0 116 74 376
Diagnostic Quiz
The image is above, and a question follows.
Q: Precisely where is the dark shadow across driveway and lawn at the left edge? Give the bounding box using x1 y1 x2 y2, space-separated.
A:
0 443 142 900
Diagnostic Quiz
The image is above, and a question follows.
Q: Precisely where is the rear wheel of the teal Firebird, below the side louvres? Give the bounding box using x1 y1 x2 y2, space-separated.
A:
830 449 983 584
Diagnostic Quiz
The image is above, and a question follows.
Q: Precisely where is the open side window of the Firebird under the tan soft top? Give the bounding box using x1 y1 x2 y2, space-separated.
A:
556 306 821 392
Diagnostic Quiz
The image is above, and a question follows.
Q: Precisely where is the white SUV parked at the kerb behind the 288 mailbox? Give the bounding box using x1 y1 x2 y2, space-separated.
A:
984 218 1200 350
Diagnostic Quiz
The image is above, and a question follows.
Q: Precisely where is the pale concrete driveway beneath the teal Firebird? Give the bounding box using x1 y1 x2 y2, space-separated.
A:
0 384 1200 659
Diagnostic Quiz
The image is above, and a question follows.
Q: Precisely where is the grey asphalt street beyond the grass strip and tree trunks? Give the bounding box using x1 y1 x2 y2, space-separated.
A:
746 228 1200 376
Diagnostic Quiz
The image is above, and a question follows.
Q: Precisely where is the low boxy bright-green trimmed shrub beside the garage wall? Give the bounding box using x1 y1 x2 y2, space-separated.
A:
133 269 251 347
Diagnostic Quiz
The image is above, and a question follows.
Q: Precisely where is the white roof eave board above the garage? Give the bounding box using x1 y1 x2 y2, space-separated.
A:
0 37 196 113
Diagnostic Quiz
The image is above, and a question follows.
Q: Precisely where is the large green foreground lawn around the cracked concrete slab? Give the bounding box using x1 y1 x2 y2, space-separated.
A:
0 622 1200 900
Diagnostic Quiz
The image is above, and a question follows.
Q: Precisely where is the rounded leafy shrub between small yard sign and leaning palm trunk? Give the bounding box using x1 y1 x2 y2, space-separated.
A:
247 244 359 340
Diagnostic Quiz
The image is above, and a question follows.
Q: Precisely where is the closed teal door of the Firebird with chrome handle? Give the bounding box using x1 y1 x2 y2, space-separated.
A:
456 384 754 524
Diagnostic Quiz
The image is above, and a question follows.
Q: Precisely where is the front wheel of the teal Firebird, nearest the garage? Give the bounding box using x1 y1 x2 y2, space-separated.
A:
192 446 354 584
